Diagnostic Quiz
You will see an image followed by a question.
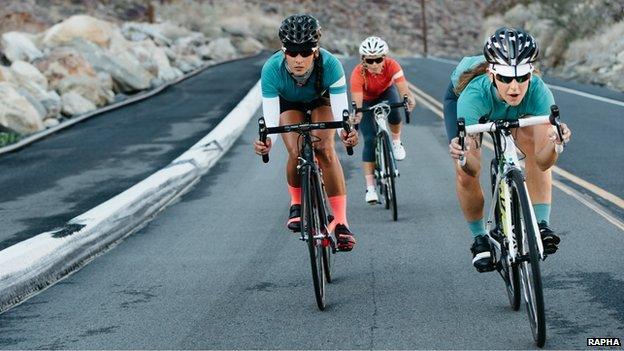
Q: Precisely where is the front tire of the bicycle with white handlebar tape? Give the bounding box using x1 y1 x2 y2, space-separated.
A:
509 170 546 347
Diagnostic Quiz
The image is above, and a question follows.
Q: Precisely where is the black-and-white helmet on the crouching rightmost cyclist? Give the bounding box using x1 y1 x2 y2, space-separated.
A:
483 27 539 66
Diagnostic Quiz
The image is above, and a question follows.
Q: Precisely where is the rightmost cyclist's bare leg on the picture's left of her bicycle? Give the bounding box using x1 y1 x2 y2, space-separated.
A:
453 148 484 222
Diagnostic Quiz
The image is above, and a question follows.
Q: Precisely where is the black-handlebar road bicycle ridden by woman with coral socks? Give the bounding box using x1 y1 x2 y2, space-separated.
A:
258 110 353 311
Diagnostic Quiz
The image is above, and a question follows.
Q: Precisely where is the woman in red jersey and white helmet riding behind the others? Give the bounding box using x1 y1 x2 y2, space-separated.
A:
351 37 415 204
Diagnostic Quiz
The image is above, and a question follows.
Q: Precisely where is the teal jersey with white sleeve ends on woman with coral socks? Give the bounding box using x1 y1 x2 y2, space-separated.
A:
261 49 347 102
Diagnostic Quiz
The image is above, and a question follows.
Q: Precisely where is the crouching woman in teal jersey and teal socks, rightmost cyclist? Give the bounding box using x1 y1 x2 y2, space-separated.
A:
444 27 571 272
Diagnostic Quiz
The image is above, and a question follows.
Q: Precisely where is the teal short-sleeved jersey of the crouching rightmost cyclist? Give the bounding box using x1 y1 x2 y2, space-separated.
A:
453 56 555 125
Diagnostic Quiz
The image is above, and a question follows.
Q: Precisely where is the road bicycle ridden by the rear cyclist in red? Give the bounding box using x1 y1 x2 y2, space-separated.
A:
351 95 410 221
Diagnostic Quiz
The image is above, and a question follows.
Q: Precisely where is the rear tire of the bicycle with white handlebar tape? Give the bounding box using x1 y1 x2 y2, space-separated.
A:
490 158 521 311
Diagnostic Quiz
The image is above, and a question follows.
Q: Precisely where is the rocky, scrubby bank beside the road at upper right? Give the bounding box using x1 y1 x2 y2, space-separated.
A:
482 0 624 91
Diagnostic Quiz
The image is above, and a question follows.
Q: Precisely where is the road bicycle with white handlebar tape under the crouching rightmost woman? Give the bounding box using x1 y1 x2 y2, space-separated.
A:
457 105 564 347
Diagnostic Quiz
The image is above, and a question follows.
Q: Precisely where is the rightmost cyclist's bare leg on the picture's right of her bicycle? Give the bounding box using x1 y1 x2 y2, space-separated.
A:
516 125 552 204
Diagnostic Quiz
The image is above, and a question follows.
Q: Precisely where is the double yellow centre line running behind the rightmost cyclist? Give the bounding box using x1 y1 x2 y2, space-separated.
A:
410 84 624 231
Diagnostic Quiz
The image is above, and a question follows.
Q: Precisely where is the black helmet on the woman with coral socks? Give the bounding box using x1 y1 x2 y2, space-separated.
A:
279 14 321 48
